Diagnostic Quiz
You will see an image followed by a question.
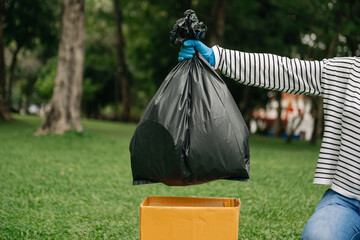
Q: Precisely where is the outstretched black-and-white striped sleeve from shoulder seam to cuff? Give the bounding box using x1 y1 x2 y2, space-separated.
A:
212 46 324 95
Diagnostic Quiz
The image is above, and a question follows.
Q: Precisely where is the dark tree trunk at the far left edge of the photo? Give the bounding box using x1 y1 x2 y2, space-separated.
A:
0 0 10 120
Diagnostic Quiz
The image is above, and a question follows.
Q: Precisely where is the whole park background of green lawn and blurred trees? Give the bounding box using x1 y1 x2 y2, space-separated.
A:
0 0 360 240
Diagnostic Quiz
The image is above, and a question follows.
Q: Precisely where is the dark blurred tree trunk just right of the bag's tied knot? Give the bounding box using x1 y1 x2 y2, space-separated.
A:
209 0 226 46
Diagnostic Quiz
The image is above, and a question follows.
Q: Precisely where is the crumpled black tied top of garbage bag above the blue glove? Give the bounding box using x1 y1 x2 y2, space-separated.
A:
170 9 207 47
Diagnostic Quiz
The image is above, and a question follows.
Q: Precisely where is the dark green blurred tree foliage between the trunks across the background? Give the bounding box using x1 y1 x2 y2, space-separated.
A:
5 0 360 127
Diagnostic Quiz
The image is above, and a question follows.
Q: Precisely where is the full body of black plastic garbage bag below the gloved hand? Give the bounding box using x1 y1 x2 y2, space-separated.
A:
130 54 250 186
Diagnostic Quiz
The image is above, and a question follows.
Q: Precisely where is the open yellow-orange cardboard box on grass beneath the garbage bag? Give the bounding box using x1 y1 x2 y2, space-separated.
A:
140 197 241 240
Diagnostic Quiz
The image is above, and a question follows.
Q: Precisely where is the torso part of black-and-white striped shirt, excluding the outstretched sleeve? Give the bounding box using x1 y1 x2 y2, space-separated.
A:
314 57 360 200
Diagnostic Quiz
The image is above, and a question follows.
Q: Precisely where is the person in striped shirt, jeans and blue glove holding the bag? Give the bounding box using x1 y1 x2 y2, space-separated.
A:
178 40 360 240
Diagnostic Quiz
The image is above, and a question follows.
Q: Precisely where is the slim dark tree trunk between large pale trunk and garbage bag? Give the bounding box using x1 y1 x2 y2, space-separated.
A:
114 0 131 121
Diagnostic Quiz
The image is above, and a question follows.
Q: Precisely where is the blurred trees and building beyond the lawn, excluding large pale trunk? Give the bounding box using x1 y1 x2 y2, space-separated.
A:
0 0 360 143
